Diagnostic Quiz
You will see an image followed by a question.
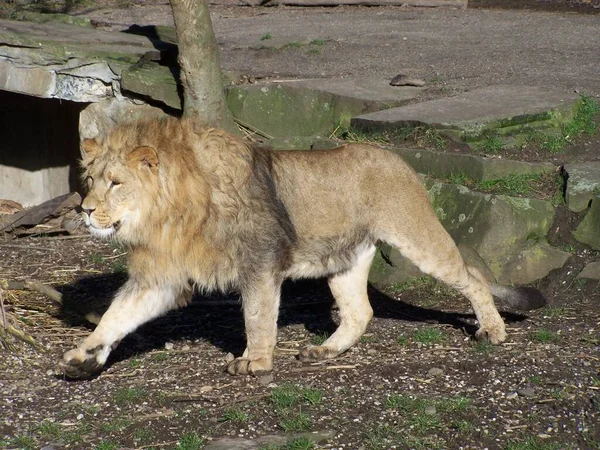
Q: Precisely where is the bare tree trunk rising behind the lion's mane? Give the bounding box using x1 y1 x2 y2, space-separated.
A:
171 0 237 132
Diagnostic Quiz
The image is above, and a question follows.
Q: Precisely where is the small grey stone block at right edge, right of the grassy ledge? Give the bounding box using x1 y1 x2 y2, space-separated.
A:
565 162 600 212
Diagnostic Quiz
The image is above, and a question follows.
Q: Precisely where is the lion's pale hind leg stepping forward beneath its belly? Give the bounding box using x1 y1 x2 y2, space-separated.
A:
299 245 375 360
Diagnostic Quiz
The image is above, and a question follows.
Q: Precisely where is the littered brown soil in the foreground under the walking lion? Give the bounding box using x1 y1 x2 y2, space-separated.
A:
0 219 600 449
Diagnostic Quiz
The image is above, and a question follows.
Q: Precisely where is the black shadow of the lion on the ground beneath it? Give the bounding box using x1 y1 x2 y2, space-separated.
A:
57 274 526 365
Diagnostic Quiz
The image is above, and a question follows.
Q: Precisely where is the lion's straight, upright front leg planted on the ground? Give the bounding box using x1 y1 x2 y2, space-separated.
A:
227 275 281 375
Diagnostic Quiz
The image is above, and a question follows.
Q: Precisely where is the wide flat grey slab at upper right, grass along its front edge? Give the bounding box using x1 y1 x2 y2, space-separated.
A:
351 85 578 141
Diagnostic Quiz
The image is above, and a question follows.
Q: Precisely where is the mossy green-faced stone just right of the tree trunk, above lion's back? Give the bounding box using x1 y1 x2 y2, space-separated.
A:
227 78 422 137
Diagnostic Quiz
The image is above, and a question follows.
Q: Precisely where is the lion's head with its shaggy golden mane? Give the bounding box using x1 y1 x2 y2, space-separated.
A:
81 118 251 247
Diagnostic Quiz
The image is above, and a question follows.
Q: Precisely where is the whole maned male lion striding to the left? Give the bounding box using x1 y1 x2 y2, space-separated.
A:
60 118 545 378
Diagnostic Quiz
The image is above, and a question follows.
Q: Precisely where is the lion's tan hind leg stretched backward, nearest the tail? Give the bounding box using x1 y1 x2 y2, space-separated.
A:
384 225 506 344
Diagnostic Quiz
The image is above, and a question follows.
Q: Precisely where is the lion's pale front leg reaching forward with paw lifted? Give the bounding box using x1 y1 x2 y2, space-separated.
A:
59 279 191 378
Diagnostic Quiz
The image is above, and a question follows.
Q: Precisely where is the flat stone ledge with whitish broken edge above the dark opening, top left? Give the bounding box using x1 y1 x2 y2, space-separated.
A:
0 20 155 103
